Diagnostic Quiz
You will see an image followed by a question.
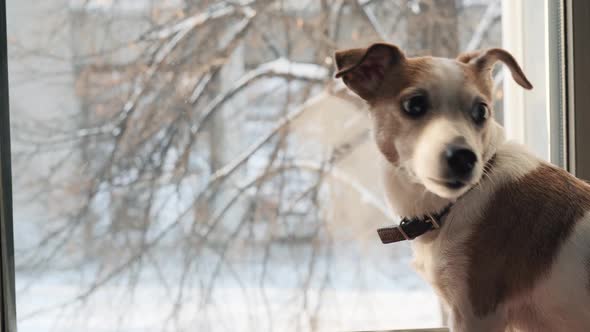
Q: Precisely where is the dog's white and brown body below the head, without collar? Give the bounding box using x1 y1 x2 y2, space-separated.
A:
384 143 590 331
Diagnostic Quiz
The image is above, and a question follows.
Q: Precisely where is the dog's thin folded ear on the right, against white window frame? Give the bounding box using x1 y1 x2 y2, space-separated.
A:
457 48 533 90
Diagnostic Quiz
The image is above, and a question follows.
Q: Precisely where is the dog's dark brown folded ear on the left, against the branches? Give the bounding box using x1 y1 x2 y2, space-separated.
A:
334 43 405 100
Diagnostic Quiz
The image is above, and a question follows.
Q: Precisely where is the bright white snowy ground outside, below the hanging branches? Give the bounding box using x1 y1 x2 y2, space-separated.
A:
16 247 440 332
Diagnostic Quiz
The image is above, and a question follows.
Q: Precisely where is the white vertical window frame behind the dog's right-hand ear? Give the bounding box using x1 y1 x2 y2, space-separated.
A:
502 0 569 169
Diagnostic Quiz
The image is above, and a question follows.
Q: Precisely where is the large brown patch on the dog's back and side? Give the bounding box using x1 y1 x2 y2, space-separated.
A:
466 165 590 316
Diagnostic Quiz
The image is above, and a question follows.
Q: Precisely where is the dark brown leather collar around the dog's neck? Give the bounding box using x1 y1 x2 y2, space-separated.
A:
377 155 496 244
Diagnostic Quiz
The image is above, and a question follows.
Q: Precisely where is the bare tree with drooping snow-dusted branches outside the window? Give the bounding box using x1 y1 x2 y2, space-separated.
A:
12 0 499 330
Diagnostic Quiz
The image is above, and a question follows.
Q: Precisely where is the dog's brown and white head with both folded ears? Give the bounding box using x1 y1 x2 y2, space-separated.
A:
335 43 532 198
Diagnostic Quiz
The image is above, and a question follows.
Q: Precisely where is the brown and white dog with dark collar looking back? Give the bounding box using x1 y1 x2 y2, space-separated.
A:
334 43 590 332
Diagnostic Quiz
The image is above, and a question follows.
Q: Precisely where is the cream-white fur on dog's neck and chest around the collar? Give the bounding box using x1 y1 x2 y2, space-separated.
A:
384 125 552 331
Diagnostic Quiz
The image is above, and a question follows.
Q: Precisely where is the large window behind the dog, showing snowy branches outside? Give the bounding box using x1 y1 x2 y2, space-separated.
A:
0 0 590 332
